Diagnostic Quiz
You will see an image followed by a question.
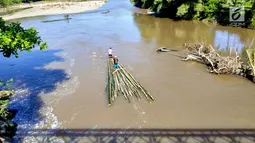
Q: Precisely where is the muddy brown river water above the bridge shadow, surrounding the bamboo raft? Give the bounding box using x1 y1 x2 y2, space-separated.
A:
0 0 255 141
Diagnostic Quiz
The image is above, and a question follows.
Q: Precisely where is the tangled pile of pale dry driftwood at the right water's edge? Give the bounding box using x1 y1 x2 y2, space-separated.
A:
183 42 254 81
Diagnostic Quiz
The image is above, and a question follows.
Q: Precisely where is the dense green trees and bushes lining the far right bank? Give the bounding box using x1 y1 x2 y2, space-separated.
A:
132 0 255 27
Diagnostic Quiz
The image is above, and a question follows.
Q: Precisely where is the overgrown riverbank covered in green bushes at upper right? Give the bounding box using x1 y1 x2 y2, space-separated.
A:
131 0 255 29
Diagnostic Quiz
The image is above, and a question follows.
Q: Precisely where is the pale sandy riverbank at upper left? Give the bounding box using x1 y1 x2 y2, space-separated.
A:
0 0 106 20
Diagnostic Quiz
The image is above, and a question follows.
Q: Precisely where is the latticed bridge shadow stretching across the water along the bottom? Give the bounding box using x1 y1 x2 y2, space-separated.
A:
13 129 255 143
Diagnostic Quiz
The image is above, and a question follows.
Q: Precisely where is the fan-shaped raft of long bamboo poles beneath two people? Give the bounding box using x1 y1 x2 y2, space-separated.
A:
107 58 155 106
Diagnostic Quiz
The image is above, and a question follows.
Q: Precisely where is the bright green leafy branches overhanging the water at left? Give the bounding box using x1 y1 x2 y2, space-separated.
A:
0 18 47 57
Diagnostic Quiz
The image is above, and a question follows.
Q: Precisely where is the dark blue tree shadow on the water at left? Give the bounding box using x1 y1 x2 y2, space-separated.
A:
0 50 69 142
